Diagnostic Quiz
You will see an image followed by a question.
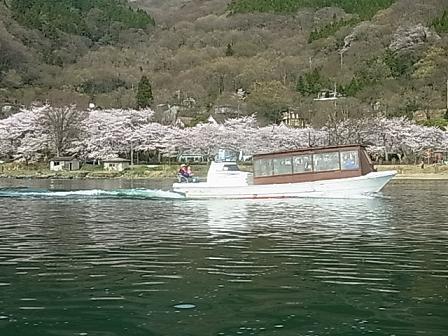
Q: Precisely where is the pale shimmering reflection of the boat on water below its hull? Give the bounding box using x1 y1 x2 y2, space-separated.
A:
201 196 390 237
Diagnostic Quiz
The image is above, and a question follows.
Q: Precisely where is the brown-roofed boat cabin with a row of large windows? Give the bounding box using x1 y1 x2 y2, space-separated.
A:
253 145 374 185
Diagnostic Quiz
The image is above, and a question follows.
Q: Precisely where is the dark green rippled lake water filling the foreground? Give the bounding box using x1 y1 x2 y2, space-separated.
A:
0 180 448 336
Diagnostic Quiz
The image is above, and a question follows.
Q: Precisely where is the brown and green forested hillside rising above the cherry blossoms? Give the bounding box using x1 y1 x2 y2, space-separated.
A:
0 0 448 124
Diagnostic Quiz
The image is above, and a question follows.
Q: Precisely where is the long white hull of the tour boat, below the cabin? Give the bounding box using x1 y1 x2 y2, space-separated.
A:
173 171 396 199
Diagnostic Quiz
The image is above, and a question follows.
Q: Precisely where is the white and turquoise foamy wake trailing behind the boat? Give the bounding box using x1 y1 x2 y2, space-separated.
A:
0 187 185 199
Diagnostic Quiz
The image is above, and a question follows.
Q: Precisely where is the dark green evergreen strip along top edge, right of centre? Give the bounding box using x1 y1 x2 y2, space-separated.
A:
229 0 395 19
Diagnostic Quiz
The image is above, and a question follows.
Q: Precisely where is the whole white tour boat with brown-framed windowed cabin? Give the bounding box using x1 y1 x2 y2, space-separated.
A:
173 145 397 199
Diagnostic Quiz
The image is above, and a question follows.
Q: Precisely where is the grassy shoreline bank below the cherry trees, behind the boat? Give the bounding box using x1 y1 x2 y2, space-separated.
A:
0 163 448 179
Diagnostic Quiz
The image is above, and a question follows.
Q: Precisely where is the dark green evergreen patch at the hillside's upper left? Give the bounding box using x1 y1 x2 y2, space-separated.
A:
10 0 154 42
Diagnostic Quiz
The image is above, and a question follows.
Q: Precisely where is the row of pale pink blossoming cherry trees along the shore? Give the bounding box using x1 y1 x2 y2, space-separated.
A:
0 106 448 162
